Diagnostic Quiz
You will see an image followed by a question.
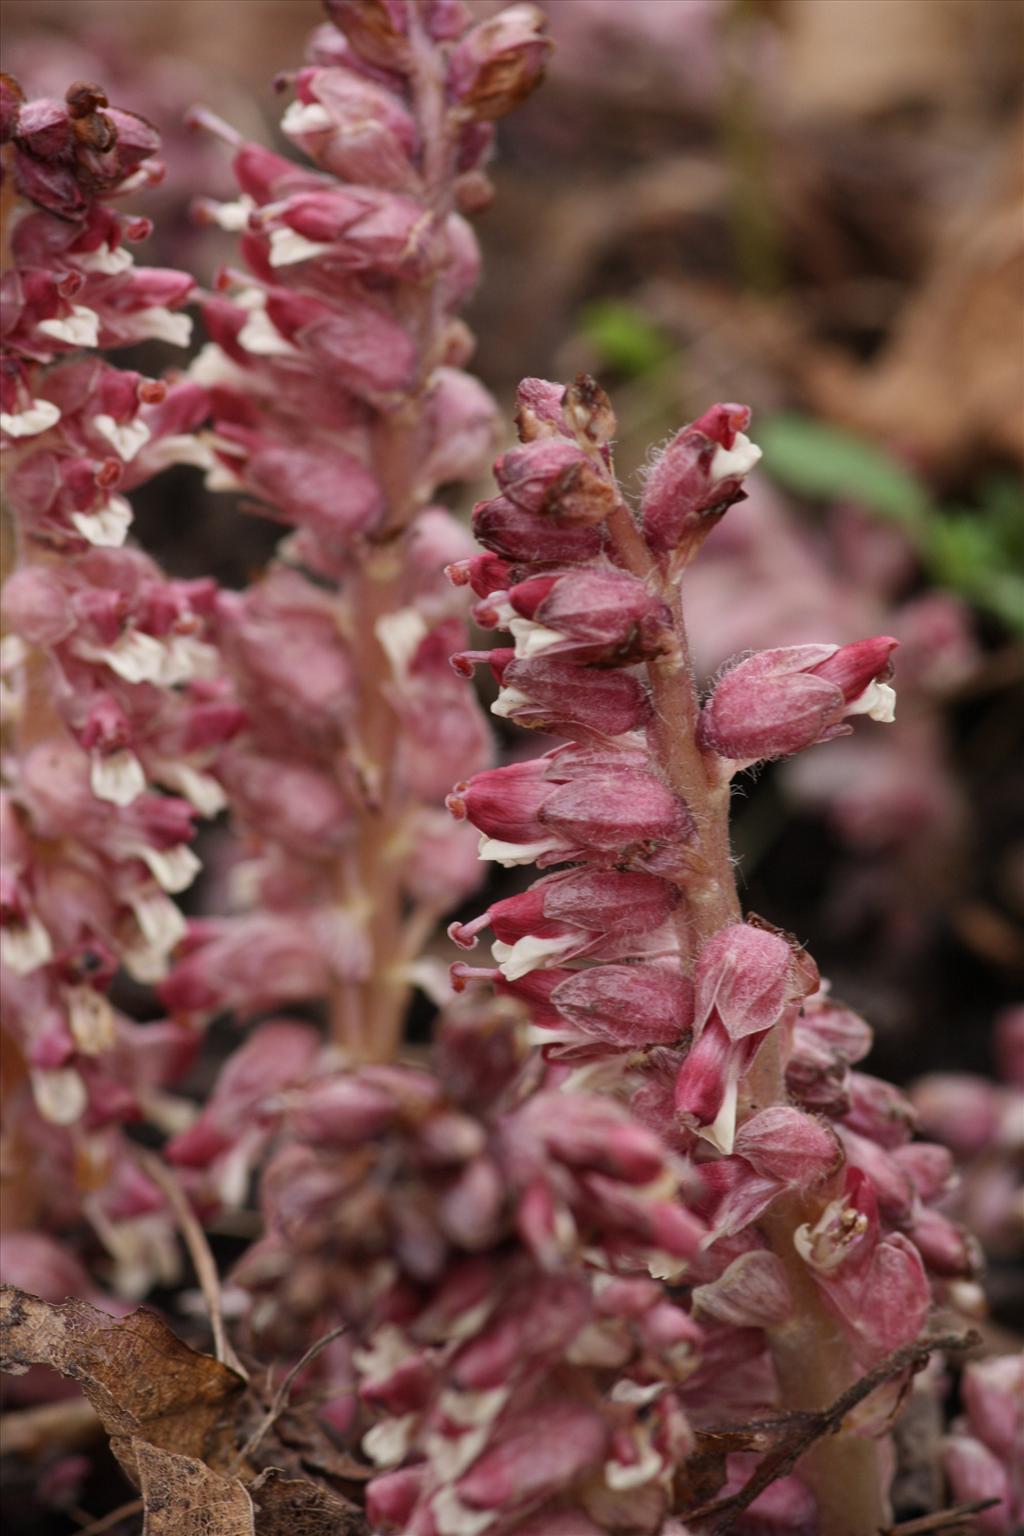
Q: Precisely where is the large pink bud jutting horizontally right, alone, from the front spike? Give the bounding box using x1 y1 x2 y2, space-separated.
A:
699 636 898 763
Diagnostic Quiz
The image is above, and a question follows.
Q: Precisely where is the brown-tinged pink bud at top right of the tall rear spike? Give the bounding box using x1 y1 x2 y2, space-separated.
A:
448 5 551 120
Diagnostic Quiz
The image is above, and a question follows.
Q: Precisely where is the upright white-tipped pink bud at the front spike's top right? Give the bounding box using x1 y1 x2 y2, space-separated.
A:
642 406 761 554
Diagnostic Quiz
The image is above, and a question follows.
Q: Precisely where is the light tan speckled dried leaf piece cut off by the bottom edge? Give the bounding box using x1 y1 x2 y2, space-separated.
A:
132 1439 254 1536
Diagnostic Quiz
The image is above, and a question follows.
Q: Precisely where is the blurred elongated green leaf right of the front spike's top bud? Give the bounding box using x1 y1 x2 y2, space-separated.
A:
755 415 929 535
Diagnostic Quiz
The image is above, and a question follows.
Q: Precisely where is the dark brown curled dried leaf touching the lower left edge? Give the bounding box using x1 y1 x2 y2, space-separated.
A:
0 1286 244 1481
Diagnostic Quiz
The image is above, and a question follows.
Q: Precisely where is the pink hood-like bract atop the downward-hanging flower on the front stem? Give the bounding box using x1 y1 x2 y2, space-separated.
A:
694 923 792 1040
